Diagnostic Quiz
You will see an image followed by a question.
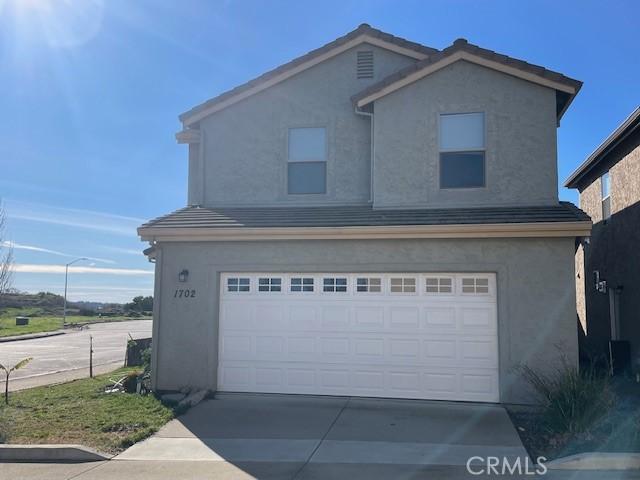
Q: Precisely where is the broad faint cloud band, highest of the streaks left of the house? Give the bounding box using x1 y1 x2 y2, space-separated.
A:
5 200 145 236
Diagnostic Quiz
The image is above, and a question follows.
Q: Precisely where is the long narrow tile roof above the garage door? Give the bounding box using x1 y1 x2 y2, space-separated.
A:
139 202 590 231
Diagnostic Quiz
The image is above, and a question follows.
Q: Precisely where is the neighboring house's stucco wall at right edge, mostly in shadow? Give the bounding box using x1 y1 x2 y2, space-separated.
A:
576 141 640 367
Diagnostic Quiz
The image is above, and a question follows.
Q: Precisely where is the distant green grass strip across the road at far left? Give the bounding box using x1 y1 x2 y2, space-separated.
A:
0 308 151 337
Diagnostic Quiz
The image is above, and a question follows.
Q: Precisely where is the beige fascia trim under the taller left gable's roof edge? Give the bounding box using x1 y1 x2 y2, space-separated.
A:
182 35 427 128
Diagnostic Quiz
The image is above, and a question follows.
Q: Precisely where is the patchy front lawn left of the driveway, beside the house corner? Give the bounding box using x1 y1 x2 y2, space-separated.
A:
0 368 174 453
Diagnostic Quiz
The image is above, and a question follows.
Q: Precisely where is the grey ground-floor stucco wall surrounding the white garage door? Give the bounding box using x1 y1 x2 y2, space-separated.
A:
153 238 578 402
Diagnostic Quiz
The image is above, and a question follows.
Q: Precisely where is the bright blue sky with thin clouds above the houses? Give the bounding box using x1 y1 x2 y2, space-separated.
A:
0 0 640 301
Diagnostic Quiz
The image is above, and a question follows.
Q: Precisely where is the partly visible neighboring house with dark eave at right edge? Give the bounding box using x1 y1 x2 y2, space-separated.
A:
565 108 640 368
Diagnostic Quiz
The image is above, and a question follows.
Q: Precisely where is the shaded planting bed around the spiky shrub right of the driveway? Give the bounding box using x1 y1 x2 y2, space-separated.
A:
507 378 640 460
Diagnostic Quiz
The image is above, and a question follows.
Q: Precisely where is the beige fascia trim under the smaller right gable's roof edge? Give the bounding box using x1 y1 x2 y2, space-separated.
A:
357 51 576 107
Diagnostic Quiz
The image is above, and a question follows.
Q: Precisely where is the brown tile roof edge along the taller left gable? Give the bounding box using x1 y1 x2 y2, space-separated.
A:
179 23 438 121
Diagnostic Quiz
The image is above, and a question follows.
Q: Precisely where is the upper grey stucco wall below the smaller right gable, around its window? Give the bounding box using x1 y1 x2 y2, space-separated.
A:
374 61 558 207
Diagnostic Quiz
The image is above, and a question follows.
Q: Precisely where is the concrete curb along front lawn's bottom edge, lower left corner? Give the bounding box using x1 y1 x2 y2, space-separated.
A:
0 444 113 463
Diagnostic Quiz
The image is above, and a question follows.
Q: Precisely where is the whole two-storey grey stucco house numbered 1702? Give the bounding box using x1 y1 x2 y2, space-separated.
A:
139 25 591 402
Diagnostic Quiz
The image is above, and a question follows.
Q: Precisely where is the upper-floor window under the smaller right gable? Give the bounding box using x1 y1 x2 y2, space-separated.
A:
440 113 485 188
